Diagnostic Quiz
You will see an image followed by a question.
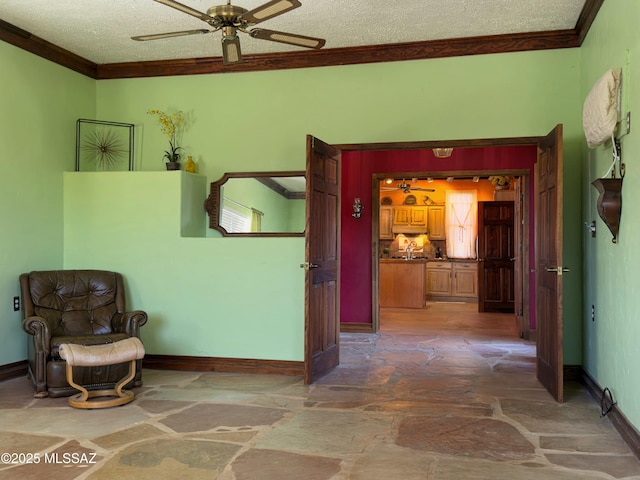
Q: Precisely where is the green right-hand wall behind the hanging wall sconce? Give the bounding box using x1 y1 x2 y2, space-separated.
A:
581 0 640 425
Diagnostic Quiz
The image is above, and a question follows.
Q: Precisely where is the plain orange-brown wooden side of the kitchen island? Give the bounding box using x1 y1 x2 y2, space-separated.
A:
380 259 427 308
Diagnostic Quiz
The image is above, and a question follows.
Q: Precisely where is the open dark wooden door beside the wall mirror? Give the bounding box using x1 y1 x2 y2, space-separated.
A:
303 135 341 384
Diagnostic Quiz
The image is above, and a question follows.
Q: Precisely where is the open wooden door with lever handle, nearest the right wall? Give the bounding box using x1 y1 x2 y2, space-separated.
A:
535 125 565 402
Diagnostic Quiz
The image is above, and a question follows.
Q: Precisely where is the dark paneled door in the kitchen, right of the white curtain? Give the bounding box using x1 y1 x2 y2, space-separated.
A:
478 201 514 313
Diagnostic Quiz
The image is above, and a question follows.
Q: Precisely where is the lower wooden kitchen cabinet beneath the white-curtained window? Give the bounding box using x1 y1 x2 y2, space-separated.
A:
426 261 478 300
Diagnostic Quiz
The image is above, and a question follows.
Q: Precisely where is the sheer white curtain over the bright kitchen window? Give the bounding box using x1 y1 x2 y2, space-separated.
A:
445 190 478 258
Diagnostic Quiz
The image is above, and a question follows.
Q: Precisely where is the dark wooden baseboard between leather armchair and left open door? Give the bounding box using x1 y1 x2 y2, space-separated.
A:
142 355 304 377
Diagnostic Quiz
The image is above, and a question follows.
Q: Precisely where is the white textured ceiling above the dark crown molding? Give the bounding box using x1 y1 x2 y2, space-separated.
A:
0 0 586 64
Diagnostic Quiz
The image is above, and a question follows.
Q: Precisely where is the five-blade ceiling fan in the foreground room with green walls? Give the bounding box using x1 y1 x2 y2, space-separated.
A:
131 0 325 65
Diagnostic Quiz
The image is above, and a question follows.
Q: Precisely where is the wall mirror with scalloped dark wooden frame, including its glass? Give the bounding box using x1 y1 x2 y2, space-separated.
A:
204 171 307 237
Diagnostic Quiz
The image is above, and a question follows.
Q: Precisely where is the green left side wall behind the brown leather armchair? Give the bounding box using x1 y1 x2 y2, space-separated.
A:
0 42 96 365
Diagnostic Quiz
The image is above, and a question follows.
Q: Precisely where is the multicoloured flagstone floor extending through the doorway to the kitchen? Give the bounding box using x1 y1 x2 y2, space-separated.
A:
0 303 640 480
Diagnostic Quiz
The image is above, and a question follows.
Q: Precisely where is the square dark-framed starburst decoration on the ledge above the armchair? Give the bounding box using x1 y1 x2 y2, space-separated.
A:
76 118 134 172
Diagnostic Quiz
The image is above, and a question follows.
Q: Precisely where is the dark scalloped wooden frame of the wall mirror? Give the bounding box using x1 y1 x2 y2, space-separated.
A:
204 170 307 237
